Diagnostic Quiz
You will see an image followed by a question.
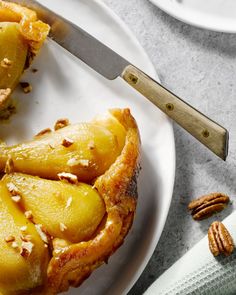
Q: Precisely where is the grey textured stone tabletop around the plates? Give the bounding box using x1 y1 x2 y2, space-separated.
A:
104 0 236 295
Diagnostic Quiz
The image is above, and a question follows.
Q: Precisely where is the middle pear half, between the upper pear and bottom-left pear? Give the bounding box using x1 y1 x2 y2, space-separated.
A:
3 173 105 243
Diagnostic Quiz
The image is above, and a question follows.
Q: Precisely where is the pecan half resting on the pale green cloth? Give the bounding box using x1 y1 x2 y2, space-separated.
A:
208 221 234 256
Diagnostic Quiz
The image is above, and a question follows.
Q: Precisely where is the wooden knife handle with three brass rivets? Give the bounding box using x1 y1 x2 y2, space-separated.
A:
121 65 228 160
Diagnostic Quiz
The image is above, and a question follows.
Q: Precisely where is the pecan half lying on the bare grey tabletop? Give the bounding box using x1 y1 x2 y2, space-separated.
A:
188 193 229 220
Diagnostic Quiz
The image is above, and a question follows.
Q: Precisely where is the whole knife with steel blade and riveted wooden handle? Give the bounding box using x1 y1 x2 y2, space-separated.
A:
8 0 229 160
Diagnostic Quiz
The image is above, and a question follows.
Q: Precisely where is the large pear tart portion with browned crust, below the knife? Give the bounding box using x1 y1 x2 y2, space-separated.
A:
0 109 140 295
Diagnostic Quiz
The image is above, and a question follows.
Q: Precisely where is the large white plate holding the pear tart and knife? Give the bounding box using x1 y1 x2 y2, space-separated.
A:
0 0 175 295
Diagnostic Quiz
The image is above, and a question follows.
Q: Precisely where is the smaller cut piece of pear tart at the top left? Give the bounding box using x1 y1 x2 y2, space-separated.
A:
0 0 49 116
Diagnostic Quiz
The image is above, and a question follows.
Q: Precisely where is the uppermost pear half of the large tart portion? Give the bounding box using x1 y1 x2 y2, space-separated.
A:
0 114 126 182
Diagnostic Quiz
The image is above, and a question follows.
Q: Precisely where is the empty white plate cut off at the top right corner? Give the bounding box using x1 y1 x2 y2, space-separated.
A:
150 0 236 33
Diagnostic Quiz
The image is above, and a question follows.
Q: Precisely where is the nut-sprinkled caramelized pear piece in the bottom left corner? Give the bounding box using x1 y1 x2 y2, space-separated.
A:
0 181 49 294
